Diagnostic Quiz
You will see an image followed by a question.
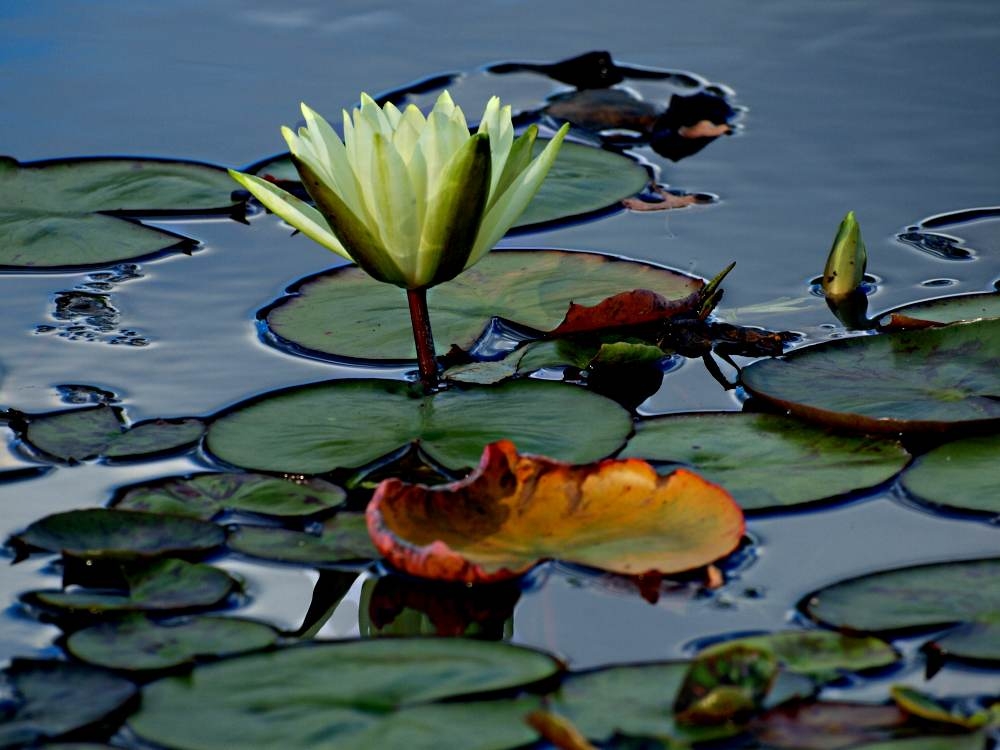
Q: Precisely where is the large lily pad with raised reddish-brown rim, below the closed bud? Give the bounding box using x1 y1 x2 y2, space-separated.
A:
741 320 1000 432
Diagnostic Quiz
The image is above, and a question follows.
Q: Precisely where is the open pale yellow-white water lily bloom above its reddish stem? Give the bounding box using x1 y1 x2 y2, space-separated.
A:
230 91 566 289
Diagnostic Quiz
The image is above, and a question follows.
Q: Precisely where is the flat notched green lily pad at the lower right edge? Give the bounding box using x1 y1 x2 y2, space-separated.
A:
802 558 1000 661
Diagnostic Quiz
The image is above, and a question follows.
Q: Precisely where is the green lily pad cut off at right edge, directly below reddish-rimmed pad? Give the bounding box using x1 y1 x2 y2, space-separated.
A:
901 435 1000 515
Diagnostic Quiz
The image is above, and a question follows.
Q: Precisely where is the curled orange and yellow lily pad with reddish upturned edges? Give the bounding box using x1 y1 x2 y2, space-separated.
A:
367 440 744 583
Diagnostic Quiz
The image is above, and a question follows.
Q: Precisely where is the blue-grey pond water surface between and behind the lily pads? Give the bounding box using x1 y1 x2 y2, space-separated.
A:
0 0 1000 748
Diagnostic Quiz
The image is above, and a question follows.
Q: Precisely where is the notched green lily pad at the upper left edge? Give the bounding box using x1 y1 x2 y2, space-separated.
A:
0 157 237 270
